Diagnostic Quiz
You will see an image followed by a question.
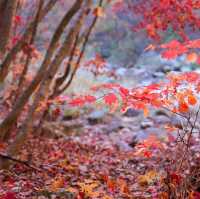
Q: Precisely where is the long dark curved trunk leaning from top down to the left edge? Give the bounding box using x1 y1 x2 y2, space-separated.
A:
0 0 83 140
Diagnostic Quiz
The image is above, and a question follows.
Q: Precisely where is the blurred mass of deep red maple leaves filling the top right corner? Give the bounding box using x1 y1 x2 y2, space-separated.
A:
113 0 200 40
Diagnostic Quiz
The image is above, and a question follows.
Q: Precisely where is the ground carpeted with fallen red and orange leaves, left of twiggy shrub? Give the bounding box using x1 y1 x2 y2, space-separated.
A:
0 110 200 199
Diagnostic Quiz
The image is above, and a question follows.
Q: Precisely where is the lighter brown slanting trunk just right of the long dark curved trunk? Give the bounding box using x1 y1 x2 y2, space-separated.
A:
1 0 91 168
